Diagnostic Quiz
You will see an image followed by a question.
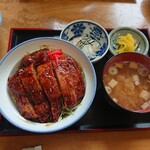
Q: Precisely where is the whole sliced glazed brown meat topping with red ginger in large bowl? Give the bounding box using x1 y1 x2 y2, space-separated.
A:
8 48 85 122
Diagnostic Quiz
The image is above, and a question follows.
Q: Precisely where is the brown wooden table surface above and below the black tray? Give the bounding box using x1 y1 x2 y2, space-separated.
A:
0 0 150 150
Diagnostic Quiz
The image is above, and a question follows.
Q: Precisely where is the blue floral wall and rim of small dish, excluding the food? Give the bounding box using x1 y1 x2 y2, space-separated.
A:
60 20 110 63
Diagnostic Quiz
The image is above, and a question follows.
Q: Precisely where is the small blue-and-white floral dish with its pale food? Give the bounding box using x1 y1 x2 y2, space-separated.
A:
60 20 109 63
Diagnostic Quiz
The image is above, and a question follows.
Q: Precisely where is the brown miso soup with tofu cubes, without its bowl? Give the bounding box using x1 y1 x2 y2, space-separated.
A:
103 61 150 111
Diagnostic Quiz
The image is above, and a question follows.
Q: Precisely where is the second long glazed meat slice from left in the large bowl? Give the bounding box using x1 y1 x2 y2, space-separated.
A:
19 64 51 122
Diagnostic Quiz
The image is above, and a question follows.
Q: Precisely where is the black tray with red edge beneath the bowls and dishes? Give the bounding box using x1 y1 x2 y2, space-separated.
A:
0 28 150 135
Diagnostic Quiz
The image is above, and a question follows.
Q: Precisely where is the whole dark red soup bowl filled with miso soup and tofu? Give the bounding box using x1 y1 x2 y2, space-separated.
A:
102 52 150 113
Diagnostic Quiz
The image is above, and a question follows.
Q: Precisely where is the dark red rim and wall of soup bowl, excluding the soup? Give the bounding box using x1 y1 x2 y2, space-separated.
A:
102 52 150 113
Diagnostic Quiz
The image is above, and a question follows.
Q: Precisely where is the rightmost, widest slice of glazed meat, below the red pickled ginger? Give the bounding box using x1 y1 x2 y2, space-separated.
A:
52 56 85 108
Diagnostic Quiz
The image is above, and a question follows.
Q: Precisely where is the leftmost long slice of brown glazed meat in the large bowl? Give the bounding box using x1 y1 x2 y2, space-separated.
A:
8 74 38 120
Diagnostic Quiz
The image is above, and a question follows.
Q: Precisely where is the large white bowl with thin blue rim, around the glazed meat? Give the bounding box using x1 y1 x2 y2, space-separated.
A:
0 37 97 133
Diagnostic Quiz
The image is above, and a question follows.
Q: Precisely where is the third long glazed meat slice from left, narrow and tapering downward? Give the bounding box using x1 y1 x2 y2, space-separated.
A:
37 61 62 122
